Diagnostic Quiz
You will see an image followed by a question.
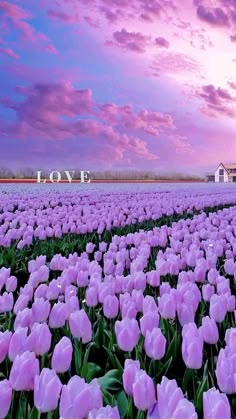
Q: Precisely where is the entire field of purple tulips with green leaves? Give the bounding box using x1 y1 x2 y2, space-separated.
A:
0 186 236 419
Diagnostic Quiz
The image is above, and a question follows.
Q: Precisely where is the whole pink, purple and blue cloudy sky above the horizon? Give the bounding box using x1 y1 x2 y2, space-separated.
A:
0 0 236 174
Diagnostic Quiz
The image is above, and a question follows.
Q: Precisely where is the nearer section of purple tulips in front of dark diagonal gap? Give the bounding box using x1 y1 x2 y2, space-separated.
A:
0 201 236 418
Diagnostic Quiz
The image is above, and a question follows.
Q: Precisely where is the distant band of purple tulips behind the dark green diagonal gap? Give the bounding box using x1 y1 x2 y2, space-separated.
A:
0 188 236 249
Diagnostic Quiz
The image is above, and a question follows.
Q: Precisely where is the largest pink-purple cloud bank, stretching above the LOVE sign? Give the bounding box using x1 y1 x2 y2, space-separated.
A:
1 83 174 160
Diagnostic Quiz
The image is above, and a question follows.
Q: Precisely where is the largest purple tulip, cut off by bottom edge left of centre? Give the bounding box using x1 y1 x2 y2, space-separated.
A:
59 376 102 419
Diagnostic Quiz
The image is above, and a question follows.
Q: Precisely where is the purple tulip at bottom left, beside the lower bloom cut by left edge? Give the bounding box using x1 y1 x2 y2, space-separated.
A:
9 351 39 391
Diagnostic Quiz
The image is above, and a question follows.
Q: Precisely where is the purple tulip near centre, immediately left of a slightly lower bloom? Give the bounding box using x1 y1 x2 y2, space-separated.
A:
115 317 140 351
